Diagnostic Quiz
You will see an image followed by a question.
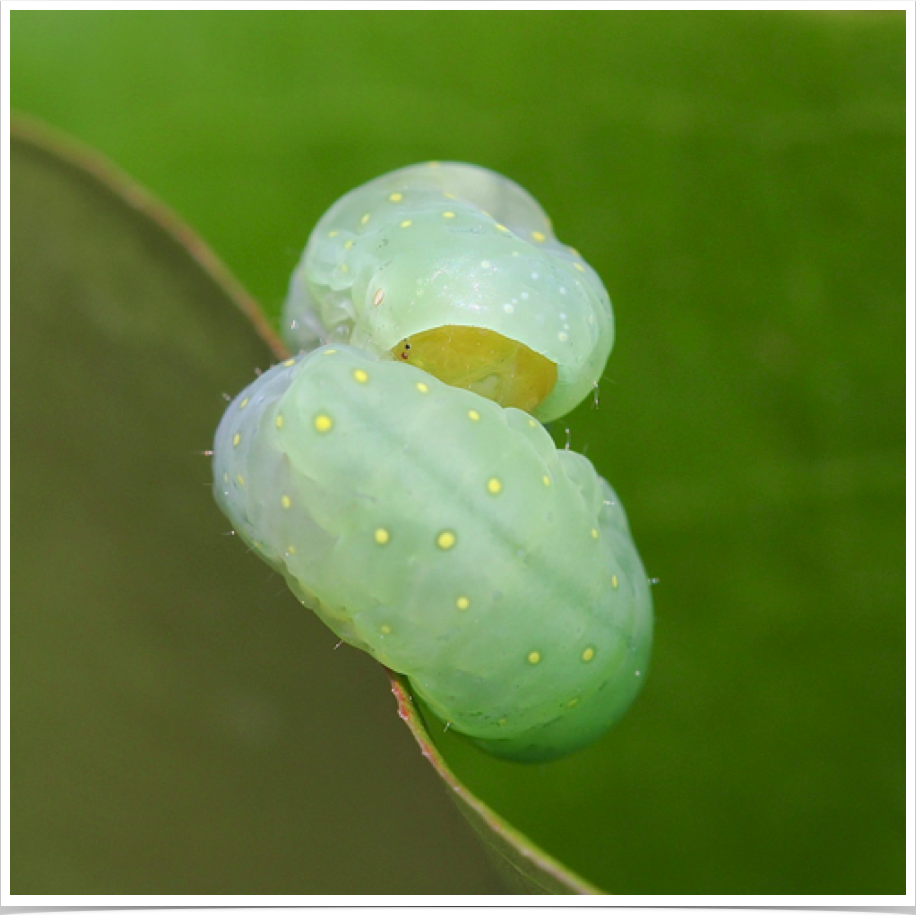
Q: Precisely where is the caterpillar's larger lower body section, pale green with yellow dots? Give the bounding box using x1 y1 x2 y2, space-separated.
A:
213 345 652 760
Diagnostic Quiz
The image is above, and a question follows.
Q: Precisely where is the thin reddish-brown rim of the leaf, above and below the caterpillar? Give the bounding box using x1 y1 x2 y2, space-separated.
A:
10 112 603 895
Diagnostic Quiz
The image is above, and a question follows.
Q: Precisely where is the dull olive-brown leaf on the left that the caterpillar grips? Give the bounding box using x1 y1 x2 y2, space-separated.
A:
10 122 508 894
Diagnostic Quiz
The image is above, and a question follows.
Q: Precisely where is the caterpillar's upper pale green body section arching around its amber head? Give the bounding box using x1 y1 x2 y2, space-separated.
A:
283 163 614 422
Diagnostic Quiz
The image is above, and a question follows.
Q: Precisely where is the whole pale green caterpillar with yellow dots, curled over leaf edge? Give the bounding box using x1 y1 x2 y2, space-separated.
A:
213 166 652 760
